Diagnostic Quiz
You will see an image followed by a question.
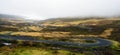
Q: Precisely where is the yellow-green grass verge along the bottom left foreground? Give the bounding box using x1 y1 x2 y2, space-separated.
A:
0 46 84 55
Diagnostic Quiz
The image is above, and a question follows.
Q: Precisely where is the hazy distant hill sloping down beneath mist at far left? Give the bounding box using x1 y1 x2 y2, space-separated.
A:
0 14 39 24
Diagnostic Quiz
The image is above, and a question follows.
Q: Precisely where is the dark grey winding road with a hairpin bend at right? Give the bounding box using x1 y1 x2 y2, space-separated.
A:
0 35 112 47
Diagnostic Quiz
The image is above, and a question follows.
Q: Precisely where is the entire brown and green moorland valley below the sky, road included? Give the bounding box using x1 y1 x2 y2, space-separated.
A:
0 15 120 55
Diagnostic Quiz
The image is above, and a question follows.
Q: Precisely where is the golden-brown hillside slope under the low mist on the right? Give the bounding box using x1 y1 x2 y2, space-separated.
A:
42 17 120 26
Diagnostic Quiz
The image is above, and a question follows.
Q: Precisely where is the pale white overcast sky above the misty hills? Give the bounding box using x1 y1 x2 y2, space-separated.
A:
0 0 120 18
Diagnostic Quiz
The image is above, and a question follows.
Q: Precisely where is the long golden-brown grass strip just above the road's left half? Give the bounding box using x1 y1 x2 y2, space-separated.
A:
11 32 69 37
